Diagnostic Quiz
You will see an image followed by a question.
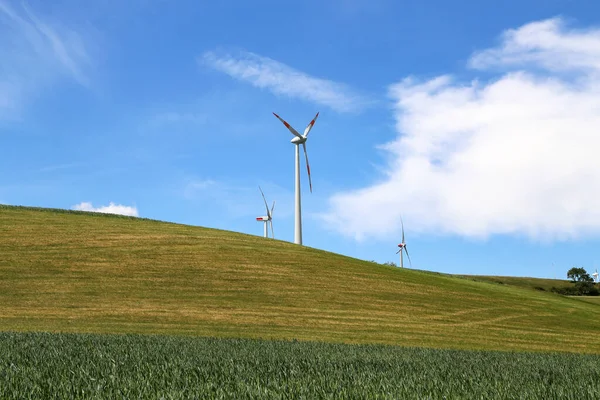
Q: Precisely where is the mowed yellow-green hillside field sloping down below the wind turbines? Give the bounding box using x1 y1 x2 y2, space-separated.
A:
0 206 600 353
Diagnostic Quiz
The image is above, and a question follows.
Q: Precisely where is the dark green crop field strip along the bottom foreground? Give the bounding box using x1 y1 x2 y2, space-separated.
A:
0 333 600 400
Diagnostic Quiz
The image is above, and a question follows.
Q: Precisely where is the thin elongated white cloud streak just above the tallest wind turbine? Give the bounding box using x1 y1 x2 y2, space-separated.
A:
199 51 367 112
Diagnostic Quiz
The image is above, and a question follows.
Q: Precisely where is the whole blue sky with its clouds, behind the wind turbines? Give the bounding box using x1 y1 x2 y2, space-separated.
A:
0 0 600 277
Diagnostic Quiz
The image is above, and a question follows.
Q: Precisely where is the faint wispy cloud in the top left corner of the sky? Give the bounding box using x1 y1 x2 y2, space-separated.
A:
0 0 91 116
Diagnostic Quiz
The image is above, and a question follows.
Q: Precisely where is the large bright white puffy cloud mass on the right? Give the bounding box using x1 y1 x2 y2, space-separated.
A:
323 19 600 241
